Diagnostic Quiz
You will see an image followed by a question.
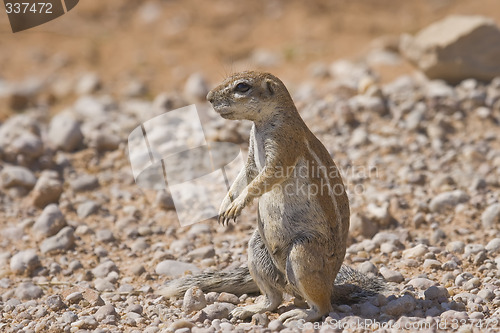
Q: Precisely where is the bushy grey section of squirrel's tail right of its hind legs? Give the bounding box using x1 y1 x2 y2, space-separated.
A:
332 265 387 304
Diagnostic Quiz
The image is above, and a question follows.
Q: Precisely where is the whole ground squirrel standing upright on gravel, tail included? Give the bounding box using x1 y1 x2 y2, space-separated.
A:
162 71 383 322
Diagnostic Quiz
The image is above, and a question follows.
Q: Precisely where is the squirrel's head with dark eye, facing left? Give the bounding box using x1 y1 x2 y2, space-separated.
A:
207 71 293 121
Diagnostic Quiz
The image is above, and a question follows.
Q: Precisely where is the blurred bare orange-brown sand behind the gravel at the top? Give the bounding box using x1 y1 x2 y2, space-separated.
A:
0 0 500 119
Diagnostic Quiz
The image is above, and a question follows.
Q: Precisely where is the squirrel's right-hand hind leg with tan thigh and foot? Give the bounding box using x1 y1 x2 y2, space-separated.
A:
279 243 335 322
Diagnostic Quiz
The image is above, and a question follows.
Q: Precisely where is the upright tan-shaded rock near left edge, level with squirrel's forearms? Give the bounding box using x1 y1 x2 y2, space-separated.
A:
31 170 63 208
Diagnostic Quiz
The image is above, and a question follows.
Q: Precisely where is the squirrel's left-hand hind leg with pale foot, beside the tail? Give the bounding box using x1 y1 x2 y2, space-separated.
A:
230 231 285 321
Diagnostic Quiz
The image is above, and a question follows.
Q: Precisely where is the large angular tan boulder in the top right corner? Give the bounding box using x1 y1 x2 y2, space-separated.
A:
400 16 500 83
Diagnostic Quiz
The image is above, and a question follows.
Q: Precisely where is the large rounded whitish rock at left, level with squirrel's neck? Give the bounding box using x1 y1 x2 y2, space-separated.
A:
47 113 83 152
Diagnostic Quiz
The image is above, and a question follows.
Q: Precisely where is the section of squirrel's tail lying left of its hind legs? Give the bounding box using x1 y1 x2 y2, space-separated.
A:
158 267 259 297
